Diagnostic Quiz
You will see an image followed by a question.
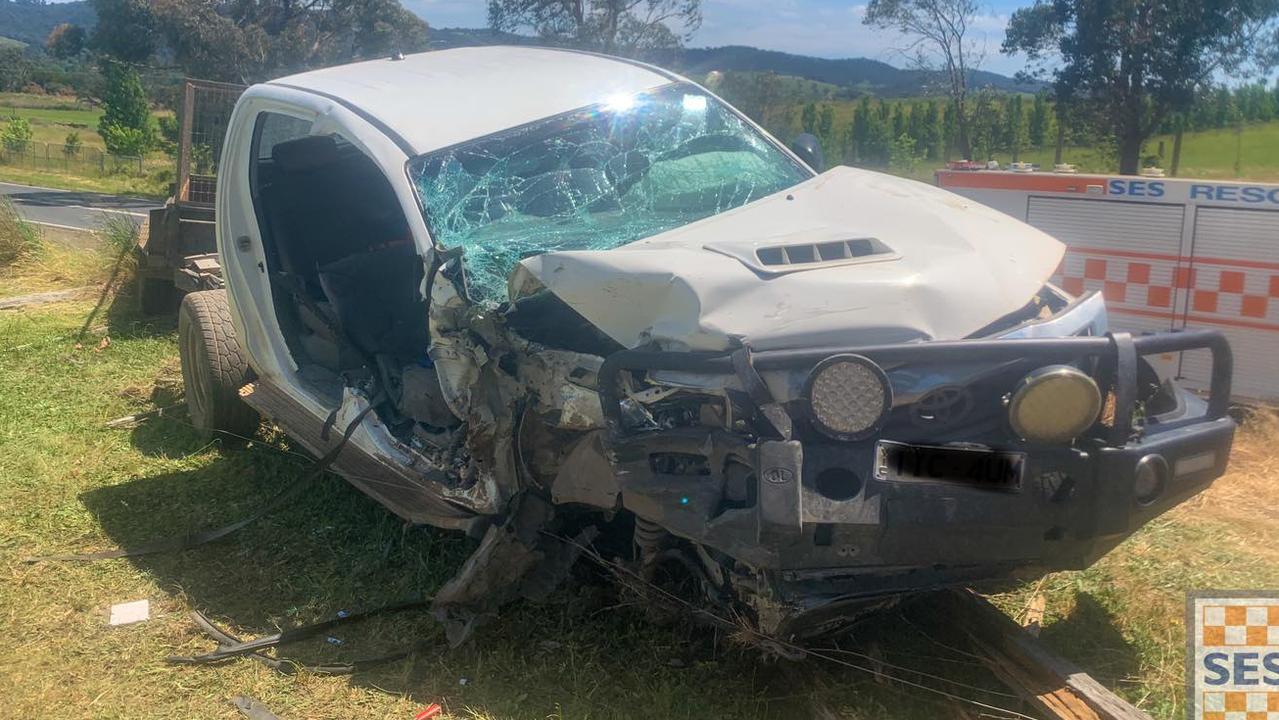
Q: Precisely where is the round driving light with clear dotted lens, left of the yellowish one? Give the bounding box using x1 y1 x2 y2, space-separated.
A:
806 356 893 440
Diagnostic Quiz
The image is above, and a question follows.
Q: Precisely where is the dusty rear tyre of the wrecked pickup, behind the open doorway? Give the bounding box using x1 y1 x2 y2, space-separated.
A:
178 290 261 439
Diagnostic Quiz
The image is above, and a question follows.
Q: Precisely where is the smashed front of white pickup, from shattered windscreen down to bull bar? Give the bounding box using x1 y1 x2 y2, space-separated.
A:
365 83 1234 642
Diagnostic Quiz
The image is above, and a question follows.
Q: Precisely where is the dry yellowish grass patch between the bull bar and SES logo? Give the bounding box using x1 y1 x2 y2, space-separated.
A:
998 411 1279 717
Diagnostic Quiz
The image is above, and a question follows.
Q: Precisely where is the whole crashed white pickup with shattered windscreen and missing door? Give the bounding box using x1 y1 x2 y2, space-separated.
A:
179 47 1234 641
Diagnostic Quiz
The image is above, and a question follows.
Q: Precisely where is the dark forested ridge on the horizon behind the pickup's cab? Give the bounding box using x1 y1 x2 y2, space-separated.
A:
431 28 1039 96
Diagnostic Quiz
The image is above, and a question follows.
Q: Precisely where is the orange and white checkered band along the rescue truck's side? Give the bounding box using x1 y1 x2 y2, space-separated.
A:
1053 247 1279 331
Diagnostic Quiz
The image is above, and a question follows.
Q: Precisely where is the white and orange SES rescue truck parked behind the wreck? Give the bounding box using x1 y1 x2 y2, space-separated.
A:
936 170 1279 402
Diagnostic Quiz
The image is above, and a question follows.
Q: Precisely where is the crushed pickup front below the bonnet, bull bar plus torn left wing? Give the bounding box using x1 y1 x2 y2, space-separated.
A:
416 246 1234 639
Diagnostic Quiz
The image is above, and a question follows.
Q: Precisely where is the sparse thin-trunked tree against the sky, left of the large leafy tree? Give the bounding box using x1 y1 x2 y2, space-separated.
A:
863 0 980 157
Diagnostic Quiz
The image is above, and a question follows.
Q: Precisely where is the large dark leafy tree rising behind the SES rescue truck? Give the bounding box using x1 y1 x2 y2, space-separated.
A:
1003 0 1279 174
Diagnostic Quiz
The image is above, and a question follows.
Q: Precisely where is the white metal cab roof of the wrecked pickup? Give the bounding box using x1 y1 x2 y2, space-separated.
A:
267 46 675 153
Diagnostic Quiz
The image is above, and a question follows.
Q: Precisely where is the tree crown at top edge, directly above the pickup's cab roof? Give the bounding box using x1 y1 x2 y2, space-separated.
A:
489 0 702 55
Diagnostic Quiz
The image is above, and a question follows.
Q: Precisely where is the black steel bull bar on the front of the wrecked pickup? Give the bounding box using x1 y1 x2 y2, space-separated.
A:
600 318 1234 637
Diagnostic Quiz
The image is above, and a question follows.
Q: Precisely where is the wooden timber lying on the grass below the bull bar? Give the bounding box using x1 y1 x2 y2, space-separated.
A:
941 591 1151 720
